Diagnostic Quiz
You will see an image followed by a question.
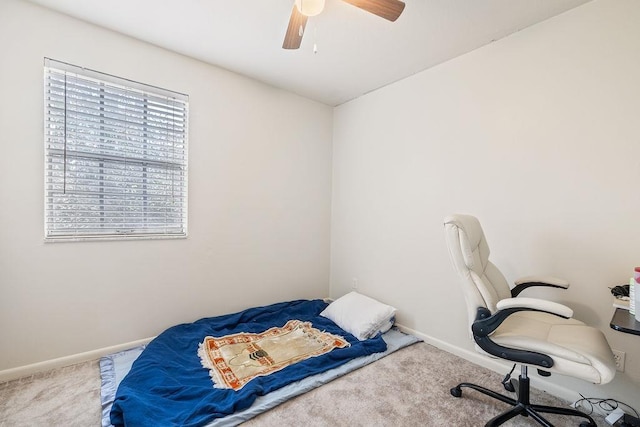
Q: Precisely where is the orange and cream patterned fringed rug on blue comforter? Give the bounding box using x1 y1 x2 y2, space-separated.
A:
198 320 350 390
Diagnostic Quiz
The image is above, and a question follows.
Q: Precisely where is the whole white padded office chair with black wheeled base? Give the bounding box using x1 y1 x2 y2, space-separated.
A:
444 215 616 427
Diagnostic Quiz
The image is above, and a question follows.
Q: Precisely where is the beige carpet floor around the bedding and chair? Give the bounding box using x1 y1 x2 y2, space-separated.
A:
0 343 607 427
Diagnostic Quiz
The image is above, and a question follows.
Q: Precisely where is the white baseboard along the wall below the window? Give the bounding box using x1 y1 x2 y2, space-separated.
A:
0 337 153 382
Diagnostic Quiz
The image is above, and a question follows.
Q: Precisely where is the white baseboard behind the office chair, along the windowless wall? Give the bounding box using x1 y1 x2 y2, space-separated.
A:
396 324 580 402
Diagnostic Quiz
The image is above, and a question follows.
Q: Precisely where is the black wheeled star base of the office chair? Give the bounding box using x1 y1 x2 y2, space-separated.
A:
451 366 596 427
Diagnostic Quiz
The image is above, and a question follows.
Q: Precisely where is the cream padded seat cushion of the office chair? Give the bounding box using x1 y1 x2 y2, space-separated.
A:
491 311 616 384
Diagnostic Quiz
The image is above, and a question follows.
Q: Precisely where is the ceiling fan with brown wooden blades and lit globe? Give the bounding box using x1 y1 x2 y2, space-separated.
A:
282 0 405 49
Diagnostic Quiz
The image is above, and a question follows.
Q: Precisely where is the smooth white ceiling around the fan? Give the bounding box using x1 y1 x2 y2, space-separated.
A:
29 0 590 105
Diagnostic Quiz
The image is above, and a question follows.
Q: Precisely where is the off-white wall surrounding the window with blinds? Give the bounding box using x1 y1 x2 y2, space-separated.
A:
0 0 332 371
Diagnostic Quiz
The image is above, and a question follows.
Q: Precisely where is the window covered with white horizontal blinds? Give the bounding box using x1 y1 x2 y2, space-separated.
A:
44 58 189 240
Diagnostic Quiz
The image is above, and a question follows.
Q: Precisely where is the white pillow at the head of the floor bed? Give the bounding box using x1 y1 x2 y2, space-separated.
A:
320 292 396 341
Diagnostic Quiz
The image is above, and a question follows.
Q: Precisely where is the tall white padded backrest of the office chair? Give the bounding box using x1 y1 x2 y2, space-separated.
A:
444 214 511 330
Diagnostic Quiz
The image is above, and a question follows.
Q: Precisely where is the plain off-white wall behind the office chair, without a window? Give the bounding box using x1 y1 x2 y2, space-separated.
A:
331 0 640 408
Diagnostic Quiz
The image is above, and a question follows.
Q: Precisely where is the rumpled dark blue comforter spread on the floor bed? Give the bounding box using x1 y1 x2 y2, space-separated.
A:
111 300 387 426
